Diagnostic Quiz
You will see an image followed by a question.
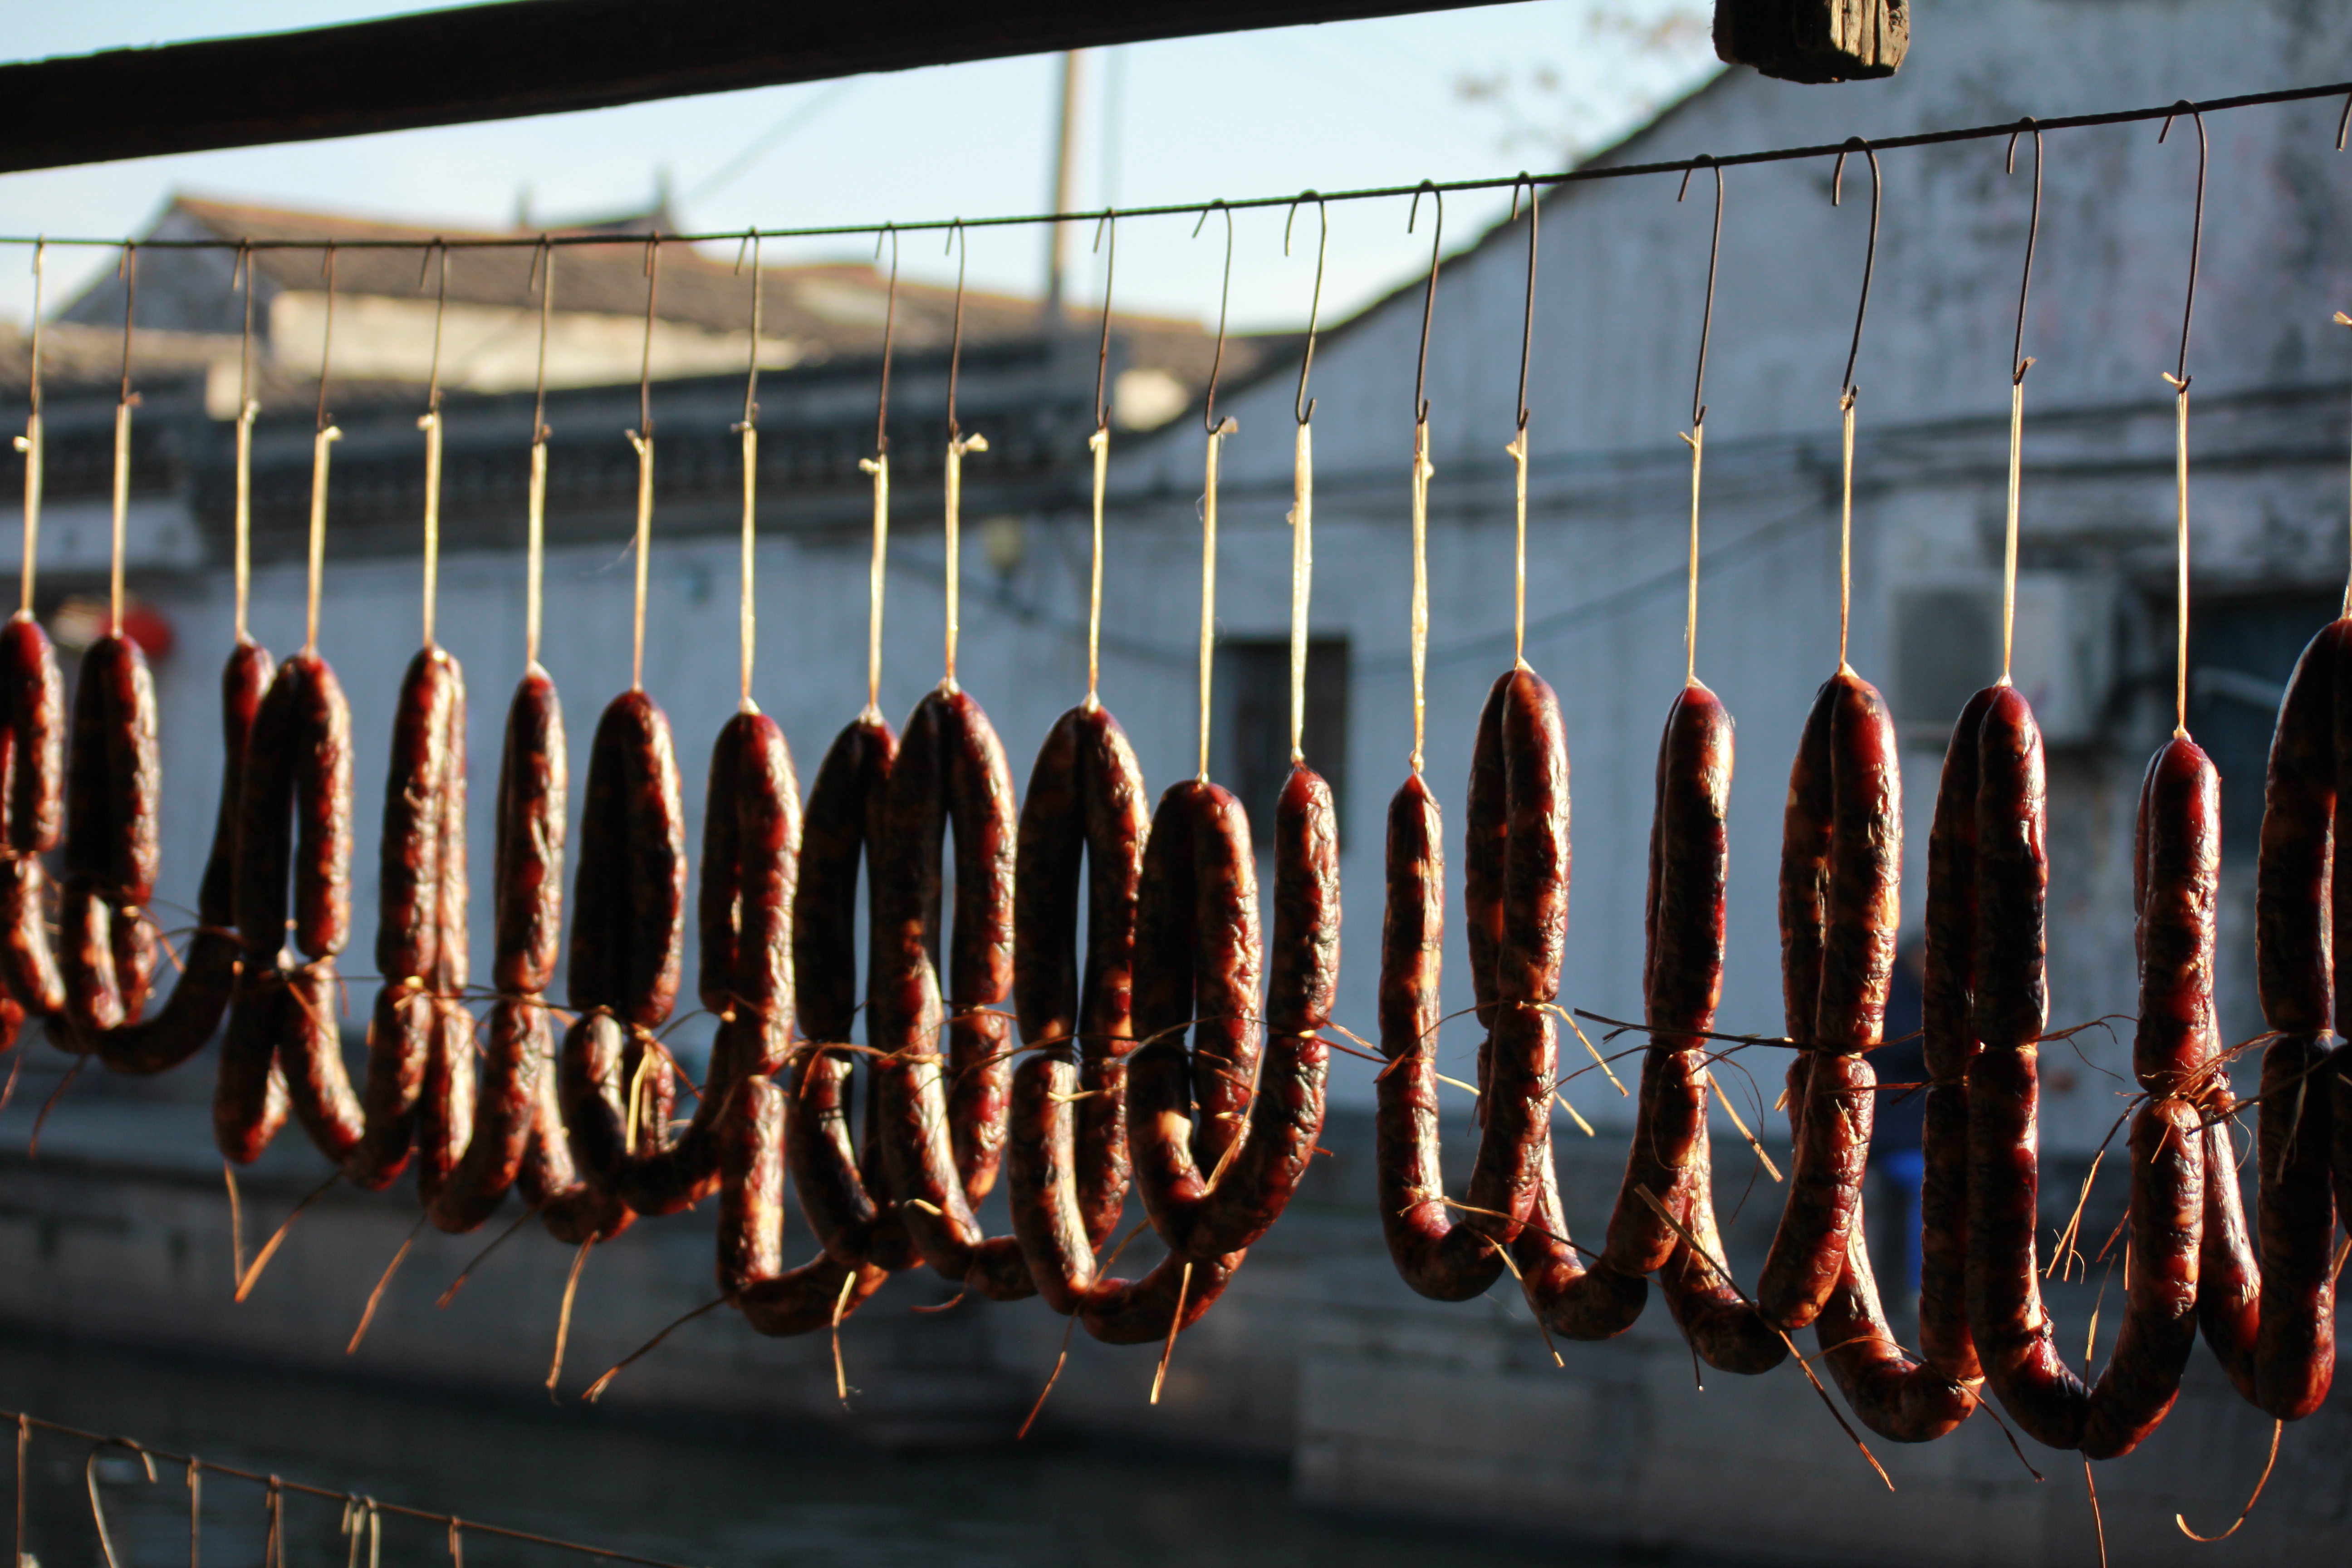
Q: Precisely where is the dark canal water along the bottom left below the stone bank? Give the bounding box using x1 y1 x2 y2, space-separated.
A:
0 1335 1618 1568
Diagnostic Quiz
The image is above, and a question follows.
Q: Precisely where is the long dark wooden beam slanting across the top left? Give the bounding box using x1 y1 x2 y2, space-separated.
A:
0 0 1477 172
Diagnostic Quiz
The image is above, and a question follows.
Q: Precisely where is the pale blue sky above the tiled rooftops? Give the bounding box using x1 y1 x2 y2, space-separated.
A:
0 0 1717 327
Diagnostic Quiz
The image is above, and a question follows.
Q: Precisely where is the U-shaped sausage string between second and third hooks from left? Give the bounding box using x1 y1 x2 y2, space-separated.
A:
44 627 270 1074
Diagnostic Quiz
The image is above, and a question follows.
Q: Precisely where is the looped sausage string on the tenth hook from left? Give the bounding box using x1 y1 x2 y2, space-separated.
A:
870 682 1037 1300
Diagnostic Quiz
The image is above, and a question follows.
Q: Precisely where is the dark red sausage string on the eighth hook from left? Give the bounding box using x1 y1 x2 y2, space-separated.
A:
699 712 889 1335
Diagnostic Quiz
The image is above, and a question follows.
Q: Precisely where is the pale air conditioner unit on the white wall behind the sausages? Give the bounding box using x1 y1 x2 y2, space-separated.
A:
1893 571 2117 745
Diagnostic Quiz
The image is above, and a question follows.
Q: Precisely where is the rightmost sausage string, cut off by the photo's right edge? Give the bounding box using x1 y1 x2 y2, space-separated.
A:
2197 621 2352 1420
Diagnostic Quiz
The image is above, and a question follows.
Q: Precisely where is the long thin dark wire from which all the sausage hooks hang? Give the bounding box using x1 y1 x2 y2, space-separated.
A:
0 82 2352 251
